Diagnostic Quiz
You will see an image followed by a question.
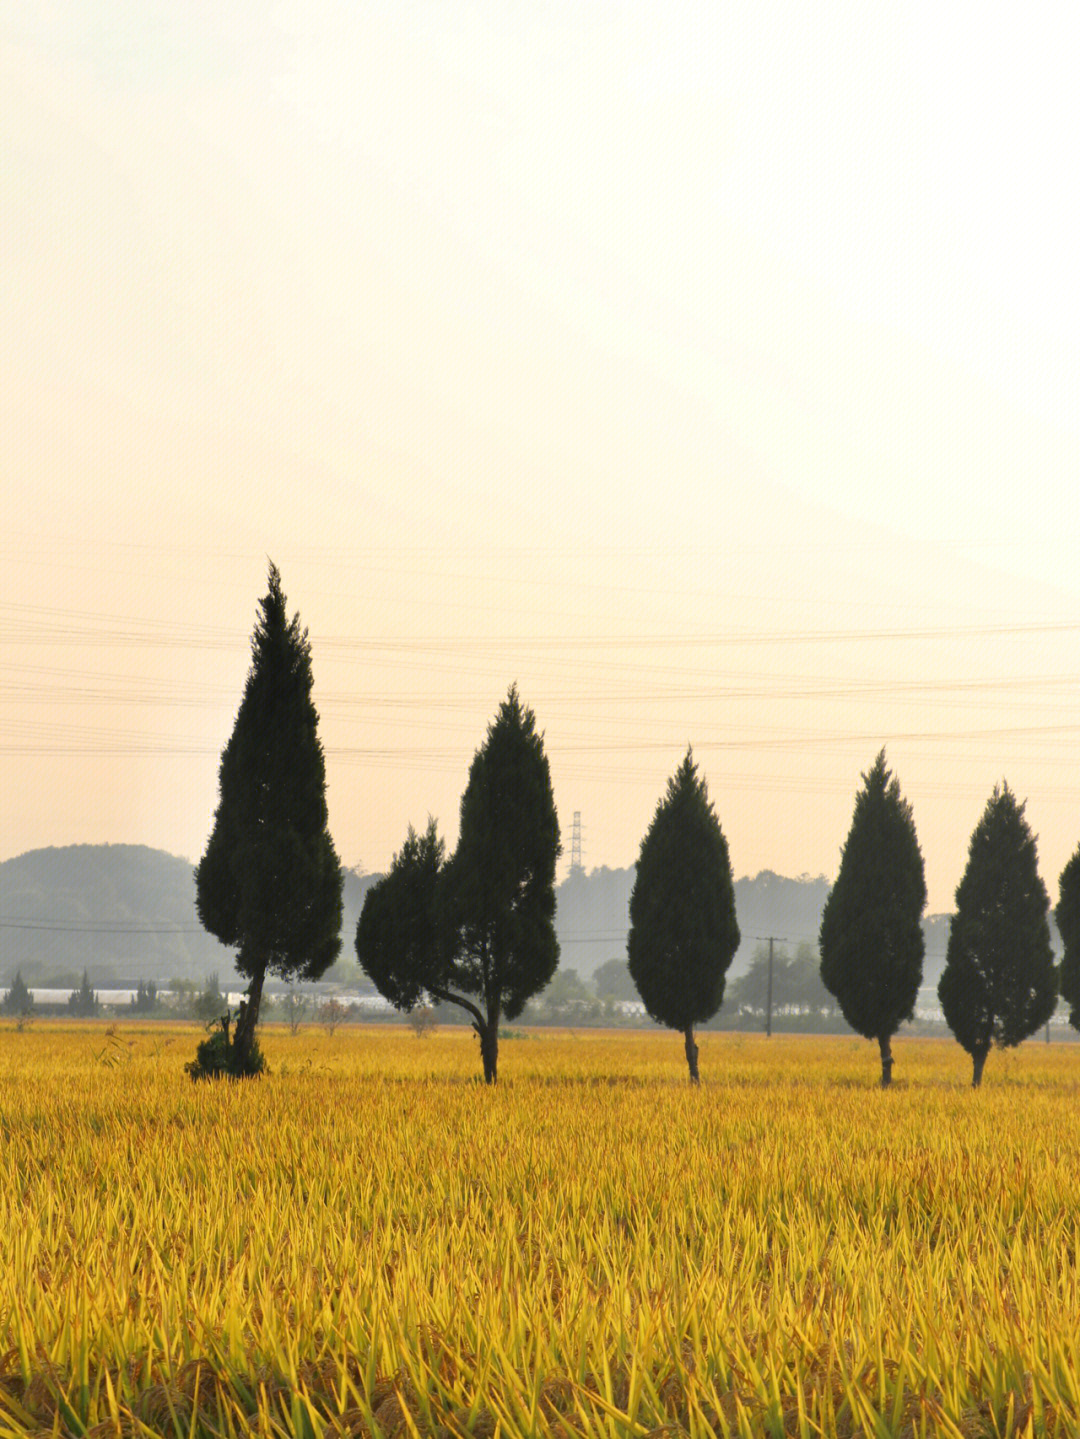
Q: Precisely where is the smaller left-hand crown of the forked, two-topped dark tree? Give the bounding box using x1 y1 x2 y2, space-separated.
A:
357 819 450 1013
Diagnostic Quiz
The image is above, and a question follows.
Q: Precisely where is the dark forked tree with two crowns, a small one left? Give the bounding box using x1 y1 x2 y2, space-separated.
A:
357 686 561 1084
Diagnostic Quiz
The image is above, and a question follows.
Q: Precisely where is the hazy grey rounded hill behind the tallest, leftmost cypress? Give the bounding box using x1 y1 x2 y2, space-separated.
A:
0 845 378 989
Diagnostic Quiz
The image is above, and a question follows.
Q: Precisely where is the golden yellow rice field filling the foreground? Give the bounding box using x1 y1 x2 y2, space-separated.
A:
0 1022 1080 1439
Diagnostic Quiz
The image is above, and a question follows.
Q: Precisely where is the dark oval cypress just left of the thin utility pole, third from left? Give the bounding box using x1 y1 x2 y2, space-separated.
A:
627 750 739 1084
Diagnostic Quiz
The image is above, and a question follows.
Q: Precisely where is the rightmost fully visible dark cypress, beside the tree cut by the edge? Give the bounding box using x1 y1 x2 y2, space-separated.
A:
938 784 1057 1086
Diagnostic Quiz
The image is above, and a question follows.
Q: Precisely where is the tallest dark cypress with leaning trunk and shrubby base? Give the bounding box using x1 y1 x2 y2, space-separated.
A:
193 564 342 1075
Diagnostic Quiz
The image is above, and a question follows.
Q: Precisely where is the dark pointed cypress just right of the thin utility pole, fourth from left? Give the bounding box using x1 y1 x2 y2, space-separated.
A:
820 750 926 1086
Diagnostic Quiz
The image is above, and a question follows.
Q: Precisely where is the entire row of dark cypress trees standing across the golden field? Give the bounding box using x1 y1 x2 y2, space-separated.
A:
173 564 1080 1085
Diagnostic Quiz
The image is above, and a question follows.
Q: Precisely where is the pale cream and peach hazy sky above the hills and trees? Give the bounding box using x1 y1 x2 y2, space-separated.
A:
0 0 1080 911
